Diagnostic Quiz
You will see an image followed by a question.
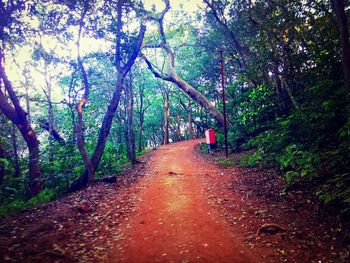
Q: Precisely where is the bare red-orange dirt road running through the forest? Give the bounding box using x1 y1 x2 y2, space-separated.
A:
108 140 257 263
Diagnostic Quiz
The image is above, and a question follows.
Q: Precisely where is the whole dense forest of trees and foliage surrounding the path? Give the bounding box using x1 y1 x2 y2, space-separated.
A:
0 0 350 228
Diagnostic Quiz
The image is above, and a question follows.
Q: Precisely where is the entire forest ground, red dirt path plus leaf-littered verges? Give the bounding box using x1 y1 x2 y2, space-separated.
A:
0 140 349 263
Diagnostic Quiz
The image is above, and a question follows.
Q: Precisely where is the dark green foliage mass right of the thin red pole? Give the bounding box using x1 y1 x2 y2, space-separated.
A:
202 0 350 222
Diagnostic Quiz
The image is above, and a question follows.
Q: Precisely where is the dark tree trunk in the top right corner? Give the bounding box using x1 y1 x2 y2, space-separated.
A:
332 0 350 93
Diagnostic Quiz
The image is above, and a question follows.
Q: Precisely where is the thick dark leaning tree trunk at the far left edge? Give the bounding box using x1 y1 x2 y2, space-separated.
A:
0 55 41 196
